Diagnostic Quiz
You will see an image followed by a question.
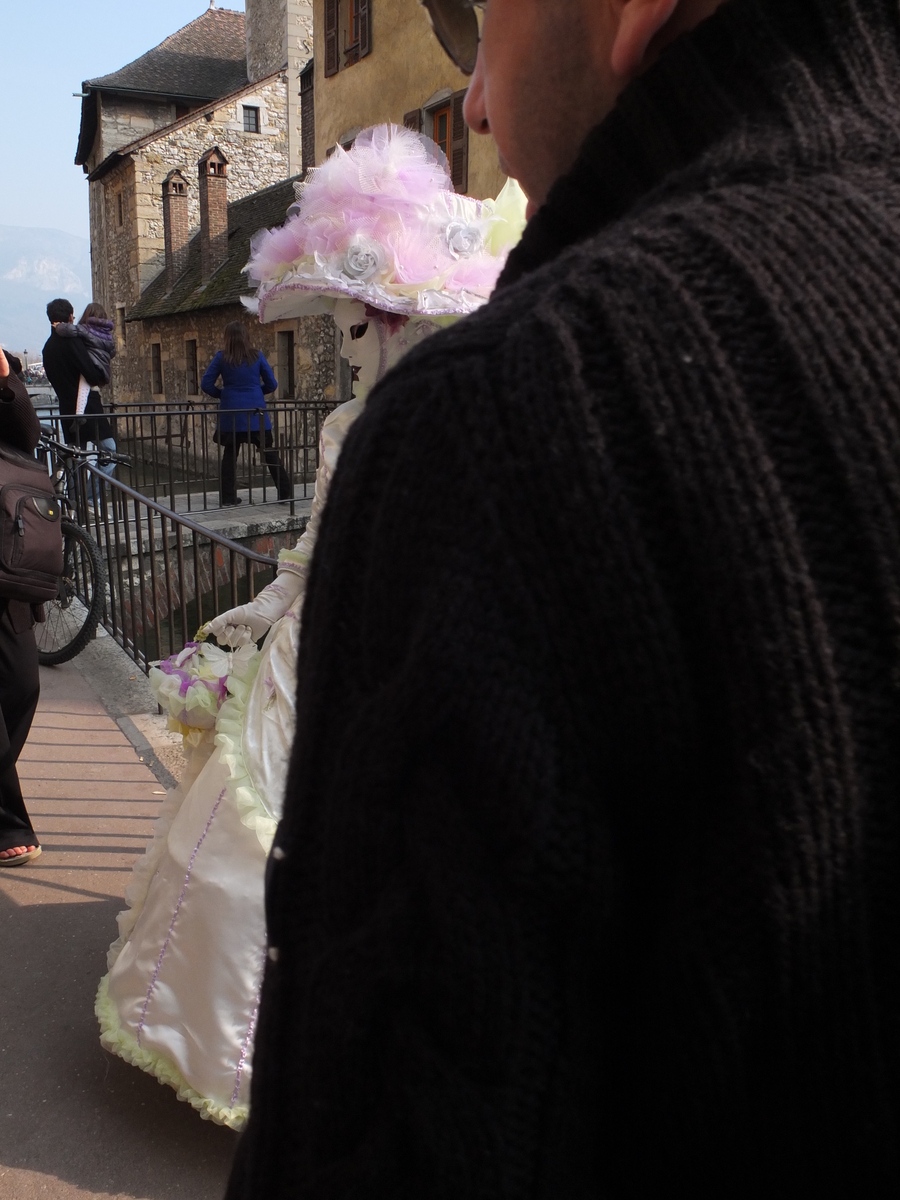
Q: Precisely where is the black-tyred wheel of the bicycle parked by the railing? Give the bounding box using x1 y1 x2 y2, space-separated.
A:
35 517 107 667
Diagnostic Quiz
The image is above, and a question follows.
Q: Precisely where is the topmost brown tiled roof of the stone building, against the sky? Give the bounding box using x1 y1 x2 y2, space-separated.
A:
84 8 247 100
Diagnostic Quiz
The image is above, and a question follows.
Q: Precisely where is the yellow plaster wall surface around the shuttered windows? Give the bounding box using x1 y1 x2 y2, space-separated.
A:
313 0 506 199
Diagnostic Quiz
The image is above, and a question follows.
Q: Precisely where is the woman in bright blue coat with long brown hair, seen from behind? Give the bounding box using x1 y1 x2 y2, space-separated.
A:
200 320 294 508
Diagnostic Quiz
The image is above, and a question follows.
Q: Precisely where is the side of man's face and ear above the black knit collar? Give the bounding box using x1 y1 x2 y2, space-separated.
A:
466 0 722 206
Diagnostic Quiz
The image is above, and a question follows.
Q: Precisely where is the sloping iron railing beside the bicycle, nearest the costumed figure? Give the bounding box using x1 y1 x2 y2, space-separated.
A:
52 451 285 671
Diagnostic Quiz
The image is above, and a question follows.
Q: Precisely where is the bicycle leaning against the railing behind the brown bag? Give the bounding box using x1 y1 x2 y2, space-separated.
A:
35 433 131 667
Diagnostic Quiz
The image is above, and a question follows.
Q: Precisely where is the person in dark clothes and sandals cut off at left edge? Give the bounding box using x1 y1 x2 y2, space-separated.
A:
0 349 41 866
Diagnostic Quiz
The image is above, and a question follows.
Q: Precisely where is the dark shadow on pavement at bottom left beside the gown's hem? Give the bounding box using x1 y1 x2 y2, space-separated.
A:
0 888 238 1200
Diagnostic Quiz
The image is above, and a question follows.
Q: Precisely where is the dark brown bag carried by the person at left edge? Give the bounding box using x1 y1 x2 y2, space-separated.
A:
0 442 62 604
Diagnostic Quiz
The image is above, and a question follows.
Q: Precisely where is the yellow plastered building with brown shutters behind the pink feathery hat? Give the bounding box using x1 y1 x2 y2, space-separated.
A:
301 0 506 199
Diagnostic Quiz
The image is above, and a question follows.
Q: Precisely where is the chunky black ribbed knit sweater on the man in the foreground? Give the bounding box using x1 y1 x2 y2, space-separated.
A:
229 0 900 1200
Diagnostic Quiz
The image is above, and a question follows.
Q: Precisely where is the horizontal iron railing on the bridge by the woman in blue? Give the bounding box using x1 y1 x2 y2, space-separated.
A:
37 400 334 514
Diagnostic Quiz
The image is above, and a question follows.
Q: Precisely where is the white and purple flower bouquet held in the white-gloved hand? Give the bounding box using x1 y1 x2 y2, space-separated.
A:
150 642 259 745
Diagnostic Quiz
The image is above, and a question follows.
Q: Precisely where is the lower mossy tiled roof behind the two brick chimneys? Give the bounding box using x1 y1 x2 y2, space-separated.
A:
127 175 300 320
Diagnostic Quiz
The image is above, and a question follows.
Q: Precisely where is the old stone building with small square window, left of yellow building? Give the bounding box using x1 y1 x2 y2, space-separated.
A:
76 0 318 404
